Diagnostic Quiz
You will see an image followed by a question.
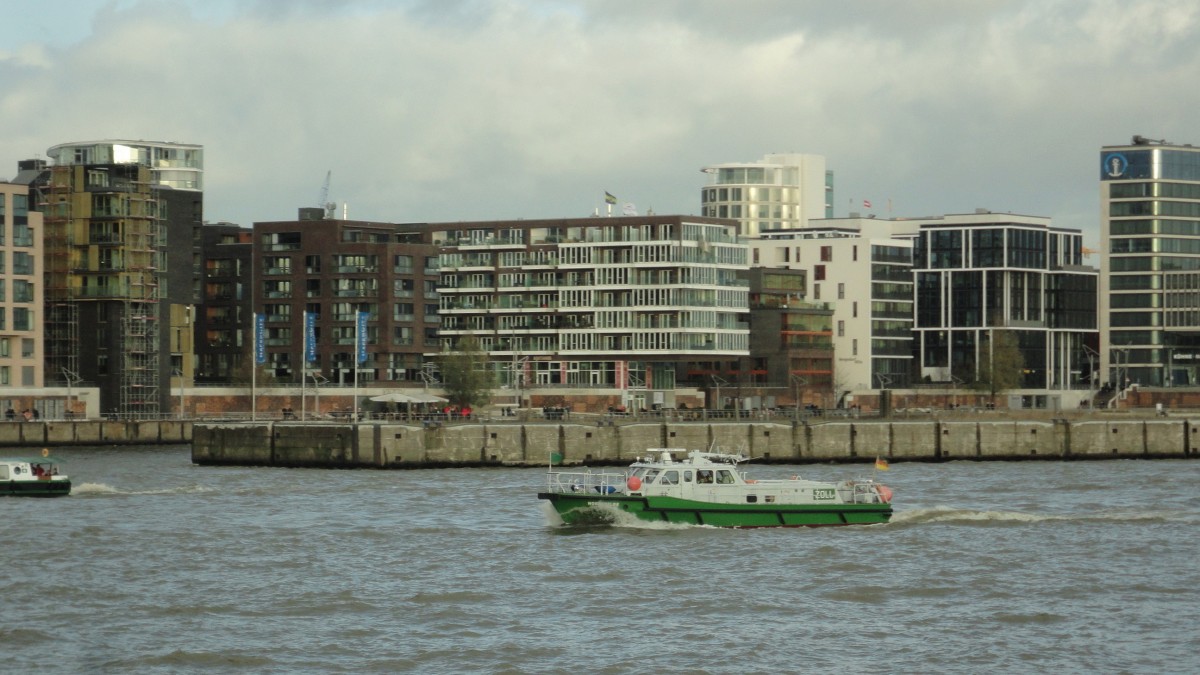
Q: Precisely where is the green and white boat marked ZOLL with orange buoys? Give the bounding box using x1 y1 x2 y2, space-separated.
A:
538 448 892 527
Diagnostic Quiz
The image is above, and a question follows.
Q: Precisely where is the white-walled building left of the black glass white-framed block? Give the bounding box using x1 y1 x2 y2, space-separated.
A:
750 217 917 398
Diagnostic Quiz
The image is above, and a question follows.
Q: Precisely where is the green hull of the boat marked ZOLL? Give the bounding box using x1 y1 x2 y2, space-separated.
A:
538 492 892 527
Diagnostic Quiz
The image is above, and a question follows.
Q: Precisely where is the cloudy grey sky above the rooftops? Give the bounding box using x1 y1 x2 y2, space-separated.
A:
0 0 1200 244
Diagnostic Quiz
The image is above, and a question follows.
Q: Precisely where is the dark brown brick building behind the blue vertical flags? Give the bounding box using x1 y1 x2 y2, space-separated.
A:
253 208 442 387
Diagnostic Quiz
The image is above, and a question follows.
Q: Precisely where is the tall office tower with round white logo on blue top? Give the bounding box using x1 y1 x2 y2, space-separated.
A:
1099 136 1200 388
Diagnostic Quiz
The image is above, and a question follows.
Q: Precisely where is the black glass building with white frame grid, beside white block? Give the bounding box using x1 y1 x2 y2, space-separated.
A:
913 209 1098 408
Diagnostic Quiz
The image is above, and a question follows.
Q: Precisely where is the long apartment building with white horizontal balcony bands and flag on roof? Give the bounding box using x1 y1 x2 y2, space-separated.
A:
432 216 750 400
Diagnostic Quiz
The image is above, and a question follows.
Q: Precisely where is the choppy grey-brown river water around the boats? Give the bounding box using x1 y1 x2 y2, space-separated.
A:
0 446 1200 674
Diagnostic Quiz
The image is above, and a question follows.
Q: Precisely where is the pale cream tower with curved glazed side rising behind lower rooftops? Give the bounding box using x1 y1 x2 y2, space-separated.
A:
700 154 833 237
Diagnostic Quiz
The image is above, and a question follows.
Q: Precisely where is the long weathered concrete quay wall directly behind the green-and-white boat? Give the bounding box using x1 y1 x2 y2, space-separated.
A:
192 418 1200 468
